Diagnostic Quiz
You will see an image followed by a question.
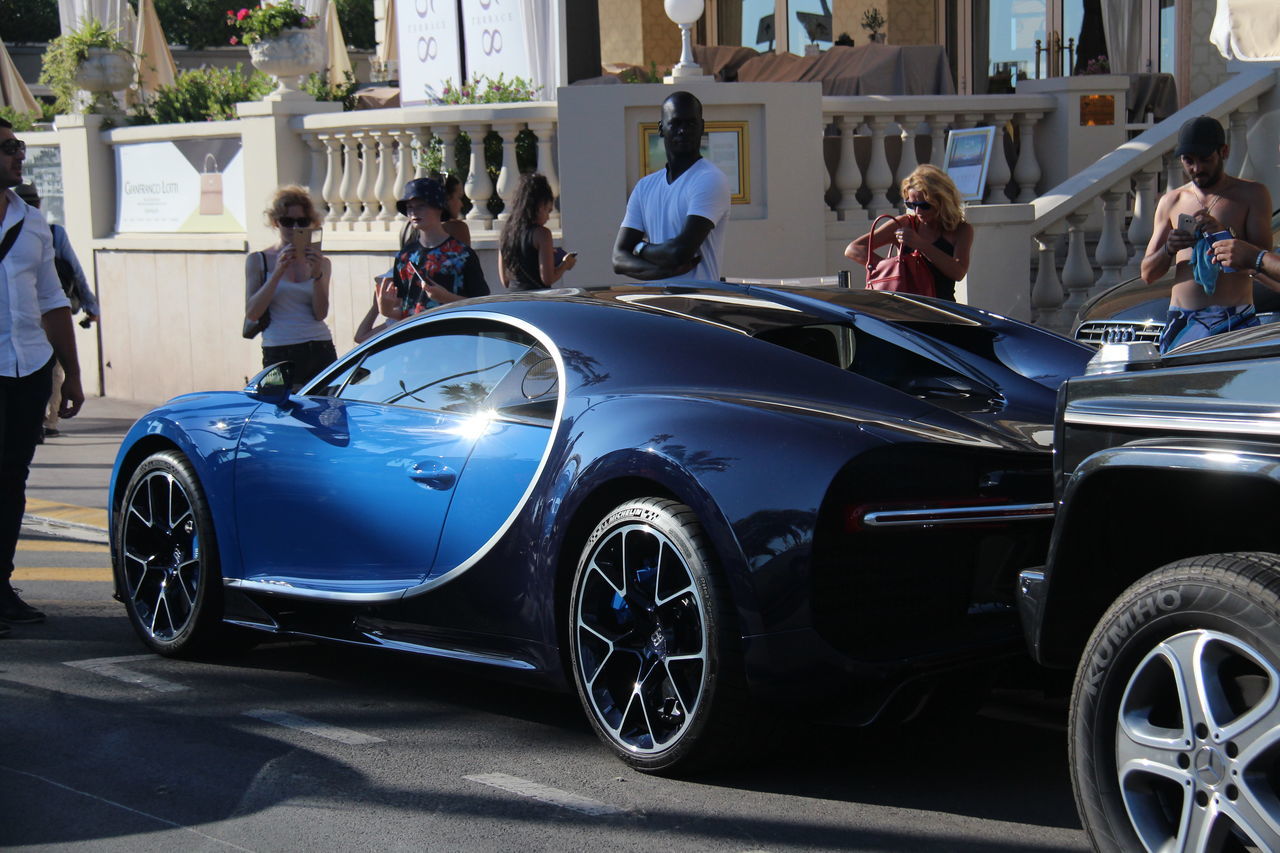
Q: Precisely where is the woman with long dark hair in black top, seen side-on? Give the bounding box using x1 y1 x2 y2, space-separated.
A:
498 172 577 291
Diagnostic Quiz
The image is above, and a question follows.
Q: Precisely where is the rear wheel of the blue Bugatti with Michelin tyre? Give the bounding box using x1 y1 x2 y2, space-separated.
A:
570 498 746 772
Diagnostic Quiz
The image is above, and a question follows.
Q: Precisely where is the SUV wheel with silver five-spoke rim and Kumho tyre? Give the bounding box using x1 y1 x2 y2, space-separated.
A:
1070 553 1280 850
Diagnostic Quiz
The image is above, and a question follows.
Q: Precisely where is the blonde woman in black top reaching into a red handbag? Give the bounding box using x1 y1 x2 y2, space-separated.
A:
845 165 973 302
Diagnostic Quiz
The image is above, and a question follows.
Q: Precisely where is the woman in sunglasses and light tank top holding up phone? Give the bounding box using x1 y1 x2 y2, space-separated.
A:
244 186 338 388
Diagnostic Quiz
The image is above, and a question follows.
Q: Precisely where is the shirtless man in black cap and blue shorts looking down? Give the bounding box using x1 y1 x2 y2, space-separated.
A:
1142 115 1271 352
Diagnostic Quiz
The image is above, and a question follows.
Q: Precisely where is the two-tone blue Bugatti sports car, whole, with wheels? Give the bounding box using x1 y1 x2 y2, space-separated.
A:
110 283 1093 772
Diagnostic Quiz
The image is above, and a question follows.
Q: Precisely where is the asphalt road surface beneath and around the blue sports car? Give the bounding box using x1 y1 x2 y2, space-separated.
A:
0 399 1088 853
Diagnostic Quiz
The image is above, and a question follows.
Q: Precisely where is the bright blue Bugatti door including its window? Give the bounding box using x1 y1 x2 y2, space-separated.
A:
234 315 529 598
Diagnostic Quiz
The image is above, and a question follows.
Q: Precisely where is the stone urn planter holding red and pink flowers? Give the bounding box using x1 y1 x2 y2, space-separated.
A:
227 0 325 100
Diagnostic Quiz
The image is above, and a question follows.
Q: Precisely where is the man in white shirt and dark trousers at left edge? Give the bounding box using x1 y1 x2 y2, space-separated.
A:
0 119 84 637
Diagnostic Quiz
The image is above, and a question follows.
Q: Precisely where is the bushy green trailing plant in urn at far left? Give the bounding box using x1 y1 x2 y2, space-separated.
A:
40 18 136 114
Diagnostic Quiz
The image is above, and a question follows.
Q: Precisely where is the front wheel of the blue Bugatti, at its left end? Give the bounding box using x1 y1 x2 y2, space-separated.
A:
111 451 221 657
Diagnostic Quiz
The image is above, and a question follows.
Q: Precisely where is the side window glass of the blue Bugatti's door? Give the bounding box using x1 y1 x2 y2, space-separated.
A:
337 321 532 414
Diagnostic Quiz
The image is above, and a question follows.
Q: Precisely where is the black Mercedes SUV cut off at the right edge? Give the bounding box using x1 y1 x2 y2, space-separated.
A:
1019 324 1280 850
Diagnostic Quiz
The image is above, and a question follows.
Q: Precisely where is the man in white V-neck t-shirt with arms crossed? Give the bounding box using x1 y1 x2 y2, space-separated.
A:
613 92 730 282
